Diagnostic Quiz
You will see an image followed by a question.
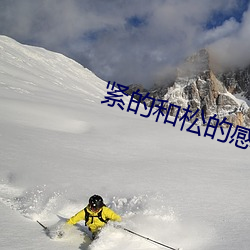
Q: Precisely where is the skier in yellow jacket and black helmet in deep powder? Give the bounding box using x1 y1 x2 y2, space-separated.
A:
67 194 122 239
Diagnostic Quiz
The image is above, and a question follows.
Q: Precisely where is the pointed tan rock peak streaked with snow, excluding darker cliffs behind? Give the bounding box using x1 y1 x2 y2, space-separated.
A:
164 50 248 126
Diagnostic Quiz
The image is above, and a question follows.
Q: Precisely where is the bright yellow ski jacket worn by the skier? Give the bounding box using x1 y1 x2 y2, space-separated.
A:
67 206 122 233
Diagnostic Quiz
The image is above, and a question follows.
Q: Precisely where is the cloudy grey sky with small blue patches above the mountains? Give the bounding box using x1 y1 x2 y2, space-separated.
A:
0 0 250 86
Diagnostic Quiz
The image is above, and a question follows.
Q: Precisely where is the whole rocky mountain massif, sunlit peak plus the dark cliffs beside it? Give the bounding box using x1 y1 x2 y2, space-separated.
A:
128 49 250 127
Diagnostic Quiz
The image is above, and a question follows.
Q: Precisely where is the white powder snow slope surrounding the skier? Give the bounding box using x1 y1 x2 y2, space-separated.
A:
0 36 250 250
